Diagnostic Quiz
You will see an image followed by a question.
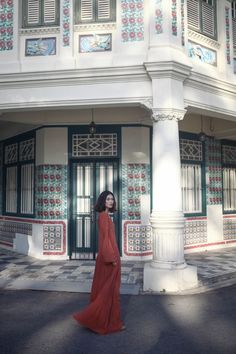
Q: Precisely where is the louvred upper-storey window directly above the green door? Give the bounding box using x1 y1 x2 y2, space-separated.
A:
75 0 116 24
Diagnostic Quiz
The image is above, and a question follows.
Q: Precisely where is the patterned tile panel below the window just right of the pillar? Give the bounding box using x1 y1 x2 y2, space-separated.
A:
184 218 207 245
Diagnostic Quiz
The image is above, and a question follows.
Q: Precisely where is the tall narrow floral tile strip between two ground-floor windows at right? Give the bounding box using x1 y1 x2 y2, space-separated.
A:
205 139 223 205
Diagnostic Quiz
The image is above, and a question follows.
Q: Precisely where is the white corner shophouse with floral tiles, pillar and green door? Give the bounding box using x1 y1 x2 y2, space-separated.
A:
0 0 236 291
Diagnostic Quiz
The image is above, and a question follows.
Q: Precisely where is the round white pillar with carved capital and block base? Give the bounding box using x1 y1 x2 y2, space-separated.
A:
144 109 197 292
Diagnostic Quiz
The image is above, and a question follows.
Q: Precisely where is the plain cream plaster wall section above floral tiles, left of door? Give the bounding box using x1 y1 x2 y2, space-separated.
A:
36 127 68 166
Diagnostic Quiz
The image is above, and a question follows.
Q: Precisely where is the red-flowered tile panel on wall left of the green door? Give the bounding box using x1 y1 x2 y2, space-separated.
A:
35 165 67 219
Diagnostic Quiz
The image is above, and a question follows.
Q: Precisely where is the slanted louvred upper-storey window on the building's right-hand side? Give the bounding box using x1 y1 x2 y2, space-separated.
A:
187 0 217 39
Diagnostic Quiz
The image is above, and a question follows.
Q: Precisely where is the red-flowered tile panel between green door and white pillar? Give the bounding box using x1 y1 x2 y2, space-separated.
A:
122 164 150 220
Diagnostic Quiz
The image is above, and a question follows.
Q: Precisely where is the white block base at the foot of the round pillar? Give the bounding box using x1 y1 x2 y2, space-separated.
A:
143 263 198 293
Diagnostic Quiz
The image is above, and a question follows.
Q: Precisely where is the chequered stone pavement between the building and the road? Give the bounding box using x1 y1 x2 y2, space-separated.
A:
0 247 236 295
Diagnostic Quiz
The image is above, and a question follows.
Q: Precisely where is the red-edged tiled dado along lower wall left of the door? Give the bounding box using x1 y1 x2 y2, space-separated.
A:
0 217 66 255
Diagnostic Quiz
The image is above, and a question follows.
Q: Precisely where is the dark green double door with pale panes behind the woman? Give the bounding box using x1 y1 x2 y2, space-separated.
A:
71 160 118 259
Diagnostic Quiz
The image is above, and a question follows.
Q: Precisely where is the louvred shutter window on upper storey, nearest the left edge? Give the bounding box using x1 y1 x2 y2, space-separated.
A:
22 0 60 28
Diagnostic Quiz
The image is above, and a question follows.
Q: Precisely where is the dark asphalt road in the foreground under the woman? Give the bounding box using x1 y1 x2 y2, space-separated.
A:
0 285 236 354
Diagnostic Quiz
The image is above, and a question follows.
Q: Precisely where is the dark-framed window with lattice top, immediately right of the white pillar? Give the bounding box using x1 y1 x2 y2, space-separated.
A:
180 133 205 216
